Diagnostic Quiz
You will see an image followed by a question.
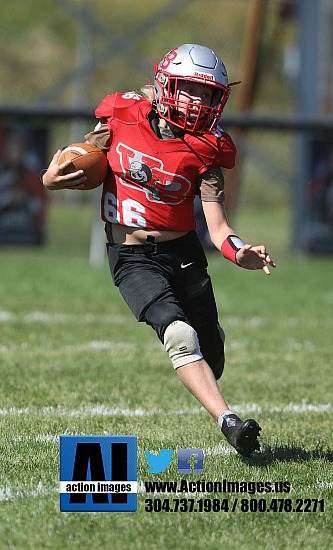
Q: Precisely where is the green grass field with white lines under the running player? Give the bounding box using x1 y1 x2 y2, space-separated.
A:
0 205 333 550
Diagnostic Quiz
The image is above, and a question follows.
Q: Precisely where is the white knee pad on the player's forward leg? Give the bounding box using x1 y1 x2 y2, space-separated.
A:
164 321 202 369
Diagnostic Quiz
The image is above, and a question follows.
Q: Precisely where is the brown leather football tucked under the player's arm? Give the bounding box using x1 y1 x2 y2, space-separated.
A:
58 143 108 190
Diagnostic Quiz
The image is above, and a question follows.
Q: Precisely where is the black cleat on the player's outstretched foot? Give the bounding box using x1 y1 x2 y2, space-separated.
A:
221 414 261 457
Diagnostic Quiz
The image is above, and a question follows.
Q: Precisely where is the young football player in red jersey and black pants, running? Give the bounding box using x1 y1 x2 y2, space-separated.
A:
43 44 275 457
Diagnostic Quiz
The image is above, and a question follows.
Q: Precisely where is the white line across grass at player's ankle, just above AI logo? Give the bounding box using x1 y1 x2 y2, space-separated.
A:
0 401 333 417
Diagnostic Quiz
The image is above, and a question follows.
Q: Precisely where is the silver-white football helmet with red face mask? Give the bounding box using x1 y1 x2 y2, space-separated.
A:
154 44 232 133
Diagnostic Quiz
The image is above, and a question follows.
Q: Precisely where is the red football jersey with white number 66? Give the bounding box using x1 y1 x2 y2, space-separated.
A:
96 92 236 231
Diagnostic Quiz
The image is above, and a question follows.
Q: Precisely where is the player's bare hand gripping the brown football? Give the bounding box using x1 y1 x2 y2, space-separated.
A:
43 149 87 191
